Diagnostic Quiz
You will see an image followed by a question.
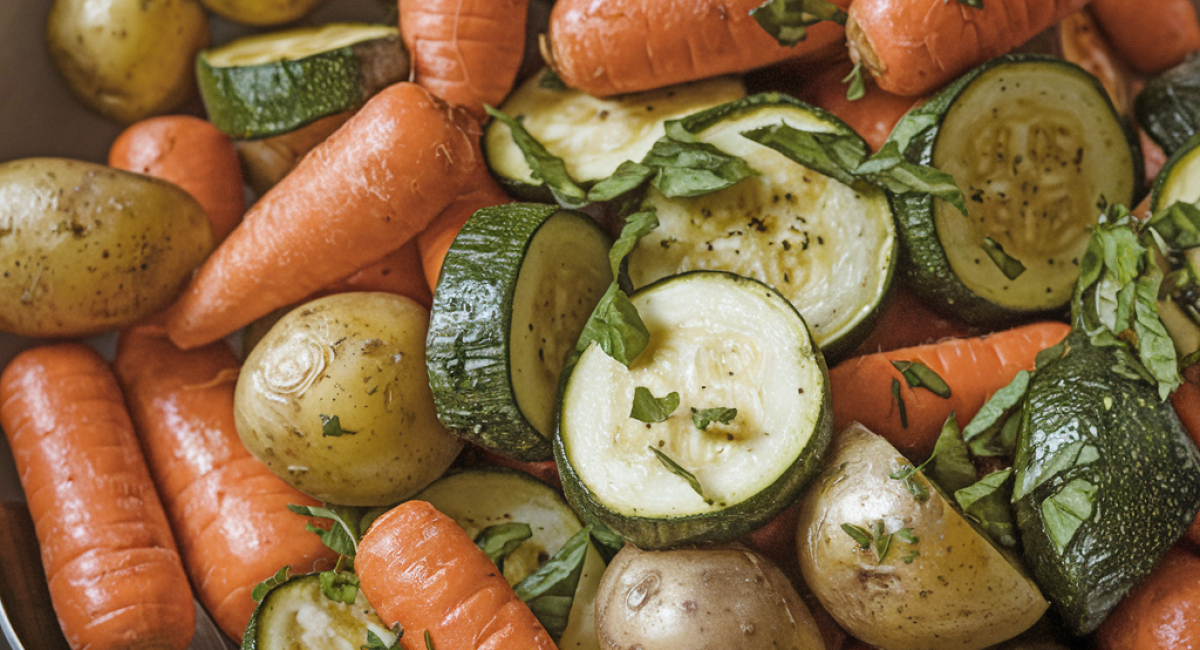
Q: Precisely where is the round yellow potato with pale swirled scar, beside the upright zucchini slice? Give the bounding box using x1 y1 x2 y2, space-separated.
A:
234 293 462 506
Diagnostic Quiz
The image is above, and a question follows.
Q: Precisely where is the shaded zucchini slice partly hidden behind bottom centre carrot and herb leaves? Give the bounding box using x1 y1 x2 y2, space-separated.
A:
414 469 605 650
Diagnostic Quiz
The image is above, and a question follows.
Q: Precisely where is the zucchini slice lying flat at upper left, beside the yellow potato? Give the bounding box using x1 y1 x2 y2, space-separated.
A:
196 23 409 138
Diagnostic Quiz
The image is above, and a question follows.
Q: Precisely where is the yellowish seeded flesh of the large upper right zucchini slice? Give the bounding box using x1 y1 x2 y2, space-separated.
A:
934 62 1134 311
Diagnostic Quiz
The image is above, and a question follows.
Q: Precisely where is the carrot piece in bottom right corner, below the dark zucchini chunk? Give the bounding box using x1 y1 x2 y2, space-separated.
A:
1096 544 1200 650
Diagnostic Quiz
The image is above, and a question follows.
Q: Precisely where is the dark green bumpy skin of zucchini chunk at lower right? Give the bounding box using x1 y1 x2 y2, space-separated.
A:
1013 332 1200 636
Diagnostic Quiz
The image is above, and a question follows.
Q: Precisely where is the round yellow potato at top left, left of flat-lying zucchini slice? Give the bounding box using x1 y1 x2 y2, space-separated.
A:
46 0 209 124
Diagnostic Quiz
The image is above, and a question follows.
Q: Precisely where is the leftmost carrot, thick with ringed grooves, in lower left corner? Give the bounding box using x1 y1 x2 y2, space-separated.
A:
0 343 196 650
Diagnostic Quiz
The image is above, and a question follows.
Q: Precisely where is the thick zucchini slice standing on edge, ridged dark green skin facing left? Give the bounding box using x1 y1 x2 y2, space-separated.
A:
425 204 612 461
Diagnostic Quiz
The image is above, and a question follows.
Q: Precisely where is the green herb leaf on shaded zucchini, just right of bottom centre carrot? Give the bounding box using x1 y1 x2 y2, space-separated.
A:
512 526 592 642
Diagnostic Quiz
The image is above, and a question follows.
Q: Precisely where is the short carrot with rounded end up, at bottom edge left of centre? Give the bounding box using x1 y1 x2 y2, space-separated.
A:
354 501 554 650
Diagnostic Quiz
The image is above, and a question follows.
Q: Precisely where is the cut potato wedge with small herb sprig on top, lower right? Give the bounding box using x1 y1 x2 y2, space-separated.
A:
797 423 1049 650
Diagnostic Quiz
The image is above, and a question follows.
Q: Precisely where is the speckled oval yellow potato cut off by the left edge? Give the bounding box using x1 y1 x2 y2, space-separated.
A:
0 158 212 337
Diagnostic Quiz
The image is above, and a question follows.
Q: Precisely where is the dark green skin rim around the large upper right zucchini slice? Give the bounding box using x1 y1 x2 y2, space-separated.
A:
893 54 1145 326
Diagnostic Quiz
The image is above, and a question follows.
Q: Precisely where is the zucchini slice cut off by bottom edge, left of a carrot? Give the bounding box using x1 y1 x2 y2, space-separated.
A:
241 573 396 650
